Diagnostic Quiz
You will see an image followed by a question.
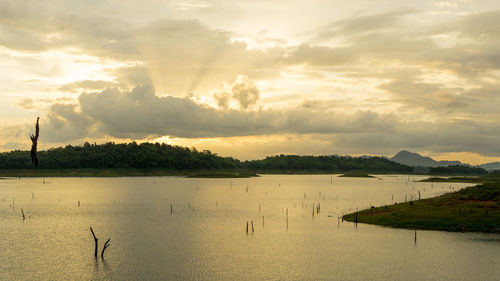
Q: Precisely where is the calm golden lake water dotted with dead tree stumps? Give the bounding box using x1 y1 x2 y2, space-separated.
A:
0 175 500 280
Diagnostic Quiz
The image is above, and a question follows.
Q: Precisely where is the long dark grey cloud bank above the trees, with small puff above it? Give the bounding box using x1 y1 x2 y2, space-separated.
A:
41 83 397 141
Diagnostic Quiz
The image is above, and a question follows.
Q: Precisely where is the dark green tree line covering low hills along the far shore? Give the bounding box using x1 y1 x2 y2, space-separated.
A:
0 142 482 173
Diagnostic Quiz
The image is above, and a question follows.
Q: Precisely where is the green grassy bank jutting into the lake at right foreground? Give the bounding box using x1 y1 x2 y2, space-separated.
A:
344 182 500 233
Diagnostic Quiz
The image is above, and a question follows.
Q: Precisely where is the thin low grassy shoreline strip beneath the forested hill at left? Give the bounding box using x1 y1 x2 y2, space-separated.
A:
0 169 257 178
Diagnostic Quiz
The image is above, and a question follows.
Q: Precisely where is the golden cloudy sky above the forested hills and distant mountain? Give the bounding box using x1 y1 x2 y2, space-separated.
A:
0 0 500 164
